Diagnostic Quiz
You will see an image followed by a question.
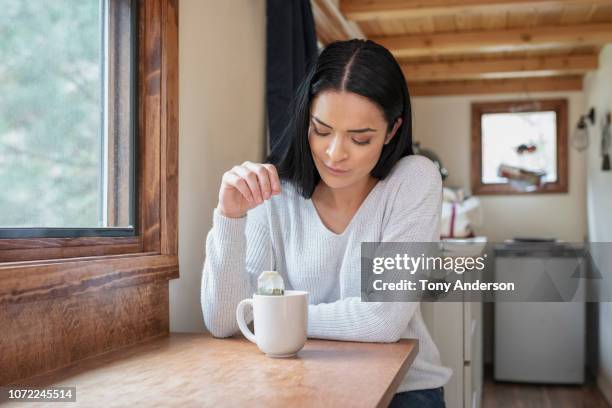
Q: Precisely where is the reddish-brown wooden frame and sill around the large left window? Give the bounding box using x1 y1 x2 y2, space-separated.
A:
0 0 178 304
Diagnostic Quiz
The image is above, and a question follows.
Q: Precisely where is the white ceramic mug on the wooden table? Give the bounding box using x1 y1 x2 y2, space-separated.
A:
236 290 308 357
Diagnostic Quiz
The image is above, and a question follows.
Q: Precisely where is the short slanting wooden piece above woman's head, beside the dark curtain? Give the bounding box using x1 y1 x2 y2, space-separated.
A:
310 0 365 45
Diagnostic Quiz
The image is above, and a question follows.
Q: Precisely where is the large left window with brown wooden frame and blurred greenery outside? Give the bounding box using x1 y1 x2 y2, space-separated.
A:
0 0 178 264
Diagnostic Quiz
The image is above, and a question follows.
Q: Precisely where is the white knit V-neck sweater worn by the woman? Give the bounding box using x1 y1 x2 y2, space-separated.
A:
201 156 452 392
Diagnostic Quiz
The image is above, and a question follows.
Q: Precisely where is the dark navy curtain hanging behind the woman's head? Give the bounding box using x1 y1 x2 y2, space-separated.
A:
266 0 317 155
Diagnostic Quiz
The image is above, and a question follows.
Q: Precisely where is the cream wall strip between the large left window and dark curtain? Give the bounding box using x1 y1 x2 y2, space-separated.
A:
170 0 265 331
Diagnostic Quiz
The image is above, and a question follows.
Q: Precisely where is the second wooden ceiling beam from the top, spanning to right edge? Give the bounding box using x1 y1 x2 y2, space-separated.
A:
371 23 612 58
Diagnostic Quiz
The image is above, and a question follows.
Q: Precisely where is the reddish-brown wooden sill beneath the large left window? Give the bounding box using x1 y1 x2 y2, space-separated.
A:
0 253 179 305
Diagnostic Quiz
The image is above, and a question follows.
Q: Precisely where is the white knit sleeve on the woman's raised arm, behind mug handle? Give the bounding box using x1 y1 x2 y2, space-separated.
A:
200 205 271 337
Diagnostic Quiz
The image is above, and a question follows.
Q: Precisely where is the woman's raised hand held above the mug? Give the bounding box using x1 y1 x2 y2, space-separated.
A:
217 161 280 218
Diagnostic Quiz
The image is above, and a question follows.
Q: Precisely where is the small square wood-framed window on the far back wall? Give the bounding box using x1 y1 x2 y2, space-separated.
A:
472 99 567 194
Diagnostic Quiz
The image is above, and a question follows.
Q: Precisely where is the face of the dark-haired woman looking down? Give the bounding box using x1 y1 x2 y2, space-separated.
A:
308 91 401 189
